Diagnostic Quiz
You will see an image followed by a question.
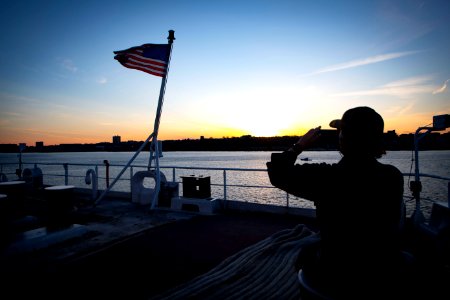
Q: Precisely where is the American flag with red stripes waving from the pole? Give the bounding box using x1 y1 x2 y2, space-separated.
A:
114 44 170 77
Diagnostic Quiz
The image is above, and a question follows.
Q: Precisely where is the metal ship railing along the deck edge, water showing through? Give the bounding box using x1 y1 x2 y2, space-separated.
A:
0 161 450 216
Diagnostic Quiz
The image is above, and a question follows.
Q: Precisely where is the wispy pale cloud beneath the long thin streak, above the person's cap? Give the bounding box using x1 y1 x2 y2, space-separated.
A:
335 76 436 97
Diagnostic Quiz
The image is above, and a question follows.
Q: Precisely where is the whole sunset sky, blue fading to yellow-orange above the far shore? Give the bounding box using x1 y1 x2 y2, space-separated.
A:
0 0 450 145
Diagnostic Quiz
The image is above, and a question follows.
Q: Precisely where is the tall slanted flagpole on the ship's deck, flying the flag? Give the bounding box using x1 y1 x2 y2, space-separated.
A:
148 30 175 210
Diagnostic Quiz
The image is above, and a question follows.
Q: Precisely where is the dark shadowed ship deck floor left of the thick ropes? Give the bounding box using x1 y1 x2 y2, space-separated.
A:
0 191 450 299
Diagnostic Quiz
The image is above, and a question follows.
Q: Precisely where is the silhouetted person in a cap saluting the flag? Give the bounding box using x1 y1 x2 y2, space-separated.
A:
267 107 412 299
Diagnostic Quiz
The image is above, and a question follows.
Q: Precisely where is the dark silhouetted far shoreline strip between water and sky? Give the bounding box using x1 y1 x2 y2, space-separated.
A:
0 130 450 153
